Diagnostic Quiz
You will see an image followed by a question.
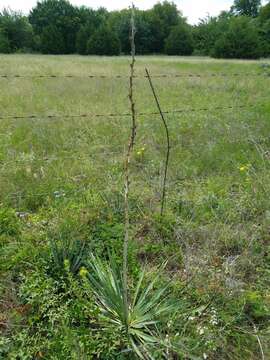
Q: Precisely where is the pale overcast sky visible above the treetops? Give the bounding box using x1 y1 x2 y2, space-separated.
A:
0 0 266 24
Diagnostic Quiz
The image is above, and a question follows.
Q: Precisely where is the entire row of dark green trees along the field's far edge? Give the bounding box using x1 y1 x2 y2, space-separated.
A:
0 0 270 59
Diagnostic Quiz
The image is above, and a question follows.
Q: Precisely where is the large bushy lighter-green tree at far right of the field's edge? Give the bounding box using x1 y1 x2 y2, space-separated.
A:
213 16 261 59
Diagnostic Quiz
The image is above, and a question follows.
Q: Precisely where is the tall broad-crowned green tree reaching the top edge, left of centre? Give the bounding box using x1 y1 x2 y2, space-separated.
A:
29 0 80 54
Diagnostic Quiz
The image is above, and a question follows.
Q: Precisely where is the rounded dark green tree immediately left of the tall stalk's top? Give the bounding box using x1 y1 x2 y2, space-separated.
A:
87 25 121 55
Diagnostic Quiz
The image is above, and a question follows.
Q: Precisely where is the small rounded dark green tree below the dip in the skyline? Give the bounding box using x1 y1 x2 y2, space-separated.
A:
165 23 193 55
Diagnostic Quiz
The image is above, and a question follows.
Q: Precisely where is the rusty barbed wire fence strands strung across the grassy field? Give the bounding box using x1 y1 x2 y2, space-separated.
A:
0 72 270 205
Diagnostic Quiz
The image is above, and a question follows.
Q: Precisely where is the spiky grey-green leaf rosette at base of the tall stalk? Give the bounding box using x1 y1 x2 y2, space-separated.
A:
88 255 174 359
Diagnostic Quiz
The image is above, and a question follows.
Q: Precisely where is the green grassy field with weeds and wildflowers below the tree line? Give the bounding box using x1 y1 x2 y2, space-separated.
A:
0 55 270 360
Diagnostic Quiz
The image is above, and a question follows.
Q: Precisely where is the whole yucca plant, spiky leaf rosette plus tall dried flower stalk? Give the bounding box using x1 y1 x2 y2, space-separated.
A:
88 14 176 360
